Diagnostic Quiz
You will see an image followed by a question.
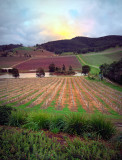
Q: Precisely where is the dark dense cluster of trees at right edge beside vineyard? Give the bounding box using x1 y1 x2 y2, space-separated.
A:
100 59 122 84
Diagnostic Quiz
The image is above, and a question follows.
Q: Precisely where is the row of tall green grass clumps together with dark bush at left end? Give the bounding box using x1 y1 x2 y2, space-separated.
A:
0 106 116 139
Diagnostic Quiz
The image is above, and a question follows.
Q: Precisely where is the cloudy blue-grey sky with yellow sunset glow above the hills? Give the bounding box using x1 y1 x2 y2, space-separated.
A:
0 0 122 46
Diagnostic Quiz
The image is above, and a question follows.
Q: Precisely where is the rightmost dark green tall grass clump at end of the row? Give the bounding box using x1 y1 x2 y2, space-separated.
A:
90 115 116 140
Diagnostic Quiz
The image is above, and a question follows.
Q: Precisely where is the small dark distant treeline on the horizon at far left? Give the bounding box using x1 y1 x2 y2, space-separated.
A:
0 44 23 51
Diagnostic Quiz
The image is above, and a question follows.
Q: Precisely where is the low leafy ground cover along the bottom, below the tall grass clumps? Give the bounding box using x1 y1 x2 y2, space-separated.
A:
0 127 121 160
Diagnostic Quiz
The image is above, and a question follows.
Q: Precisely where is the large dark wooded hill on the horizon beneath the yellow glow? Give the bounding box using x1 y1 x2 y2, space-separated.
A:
38 35 122 54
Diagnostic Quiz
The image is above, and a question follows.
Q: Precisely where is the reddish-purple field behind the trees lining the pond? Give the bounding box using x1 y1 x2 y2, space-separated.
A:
15 56 81 70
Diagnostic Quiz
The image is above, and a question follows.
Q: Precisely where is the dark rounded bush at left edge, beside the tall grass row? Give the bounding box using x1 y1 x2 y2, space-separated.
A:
0 106 12 125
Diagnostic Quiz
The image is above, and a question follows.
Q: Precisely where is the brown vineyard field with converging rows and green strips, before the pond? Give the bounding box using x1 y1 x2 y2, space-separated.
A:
0 77 122 116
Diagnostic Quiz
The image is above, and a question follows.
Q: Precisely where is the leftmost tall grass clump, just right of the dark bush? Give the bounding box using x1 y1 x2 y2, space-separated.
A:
9 110 28 127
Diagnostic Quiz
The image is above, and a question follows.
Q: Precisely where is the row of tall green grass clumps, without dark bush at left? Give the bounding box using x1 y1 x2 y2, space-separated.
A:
3 107 115 139
